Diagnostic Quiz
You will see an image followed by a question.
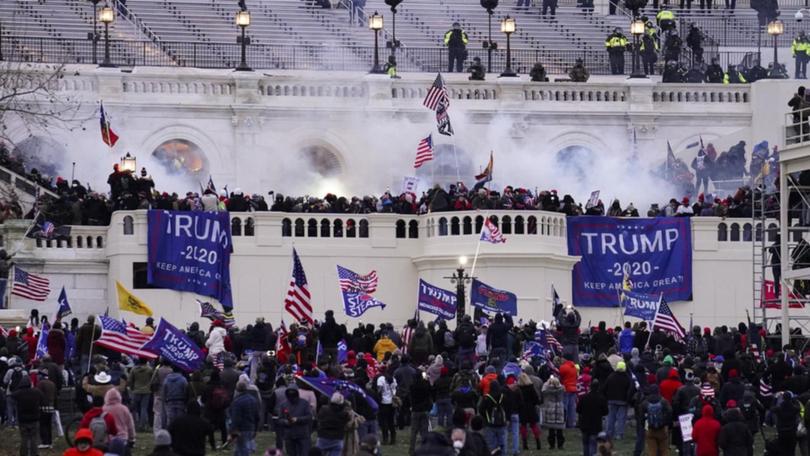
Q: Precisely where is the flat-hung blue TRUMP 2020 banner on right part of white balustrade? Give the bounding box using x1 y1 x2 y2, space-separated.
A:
567 216 692 307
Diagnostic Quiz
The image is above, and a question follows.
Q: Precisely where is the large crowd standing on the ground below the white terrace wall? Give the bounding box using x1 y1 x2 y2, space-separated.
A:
0 306 810 456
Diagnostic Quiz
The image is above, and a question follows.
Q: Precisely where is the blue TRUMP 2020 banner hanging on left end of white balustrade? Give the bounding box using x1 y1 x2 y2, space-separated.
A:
147 210 233 310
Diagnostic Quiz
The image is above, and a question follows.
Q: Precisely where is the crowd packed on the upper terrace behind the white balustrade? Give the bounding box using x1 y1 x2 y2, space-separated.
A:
0 141 778 226
